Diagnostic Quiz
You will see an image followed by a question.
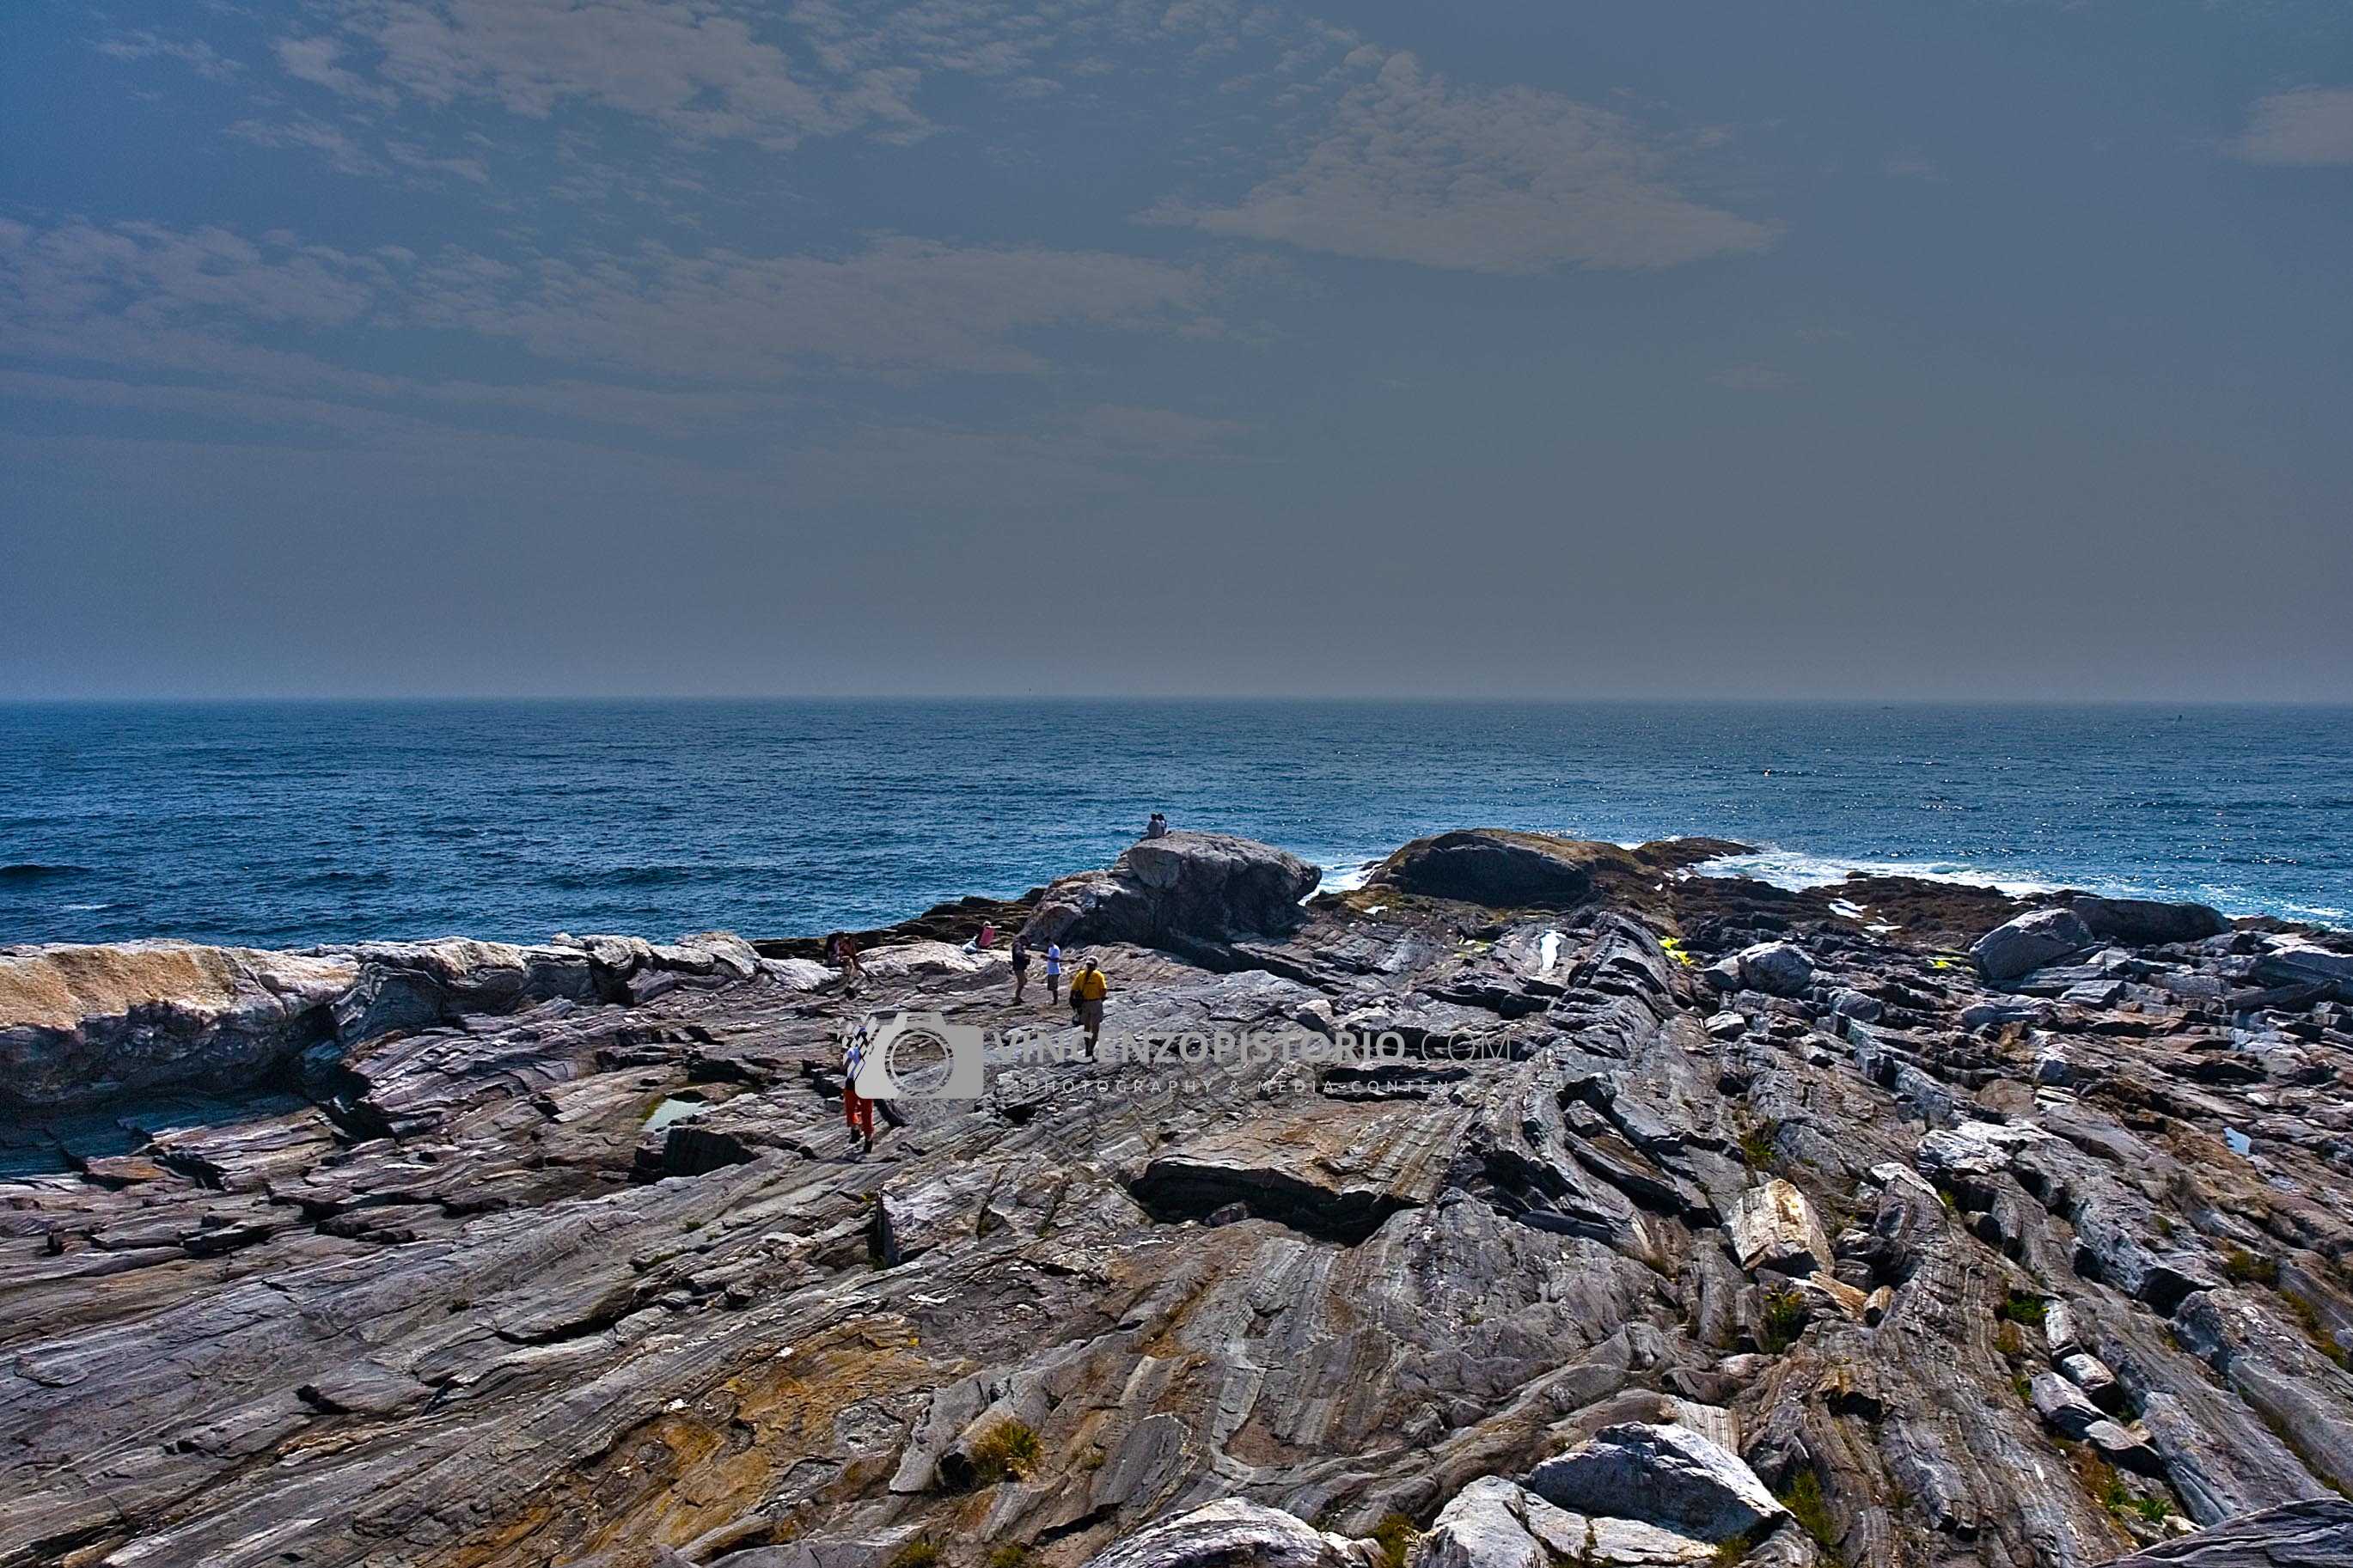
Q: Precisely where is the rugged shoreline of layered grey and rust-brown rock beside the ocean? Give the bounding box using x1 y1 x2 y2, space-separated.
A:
0 830 2353 1568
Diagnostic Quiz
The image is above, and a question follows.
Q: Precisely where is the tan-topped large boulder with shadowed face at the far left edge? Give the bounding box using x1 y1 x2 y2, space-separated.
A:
0 940 360 1109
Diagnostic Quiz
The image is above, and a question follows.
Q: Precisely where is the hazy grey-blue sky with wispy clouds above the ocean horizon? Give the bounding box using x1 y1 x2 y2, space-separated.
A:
0 0 2353 700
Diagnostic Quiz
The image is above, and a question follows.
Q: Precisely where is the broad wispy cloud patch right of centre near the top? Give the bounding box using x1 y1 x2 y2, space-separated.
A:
1146 49 1772 272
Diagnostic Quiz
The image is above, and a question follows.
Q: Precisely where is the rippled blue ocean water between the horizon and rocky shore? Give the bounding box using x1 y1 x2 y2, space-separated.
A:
0 700 2353 945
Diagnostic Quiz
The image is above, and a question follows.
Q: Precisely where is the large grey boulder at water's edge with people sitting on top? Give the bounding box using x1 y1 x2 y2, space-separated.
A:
1021 833 1323 948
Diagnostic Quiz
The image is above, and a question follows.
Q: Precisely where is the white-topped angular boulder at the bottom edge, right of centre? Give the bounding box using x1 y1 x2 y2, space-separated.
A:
1527 1422 1788 1540
